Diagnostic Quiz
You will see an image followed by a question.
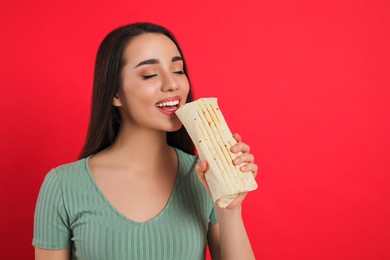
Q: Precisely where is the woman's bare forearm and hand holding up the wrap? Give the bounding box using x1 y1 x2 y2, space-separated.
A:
196 134 258 260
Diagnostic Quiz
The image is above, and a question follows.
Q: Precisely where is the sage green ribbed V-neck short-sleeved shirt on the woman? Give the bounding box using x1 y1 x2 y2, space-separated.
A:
33 149 217 260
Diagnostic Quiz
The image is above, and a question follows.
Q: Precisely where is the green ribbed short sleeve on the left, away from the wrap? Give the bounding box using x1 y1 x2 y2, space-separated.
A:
32 169 70 250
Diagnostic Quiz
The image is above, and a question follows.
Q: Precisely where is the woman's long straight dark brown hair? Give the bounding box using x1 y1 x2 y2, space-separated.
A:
79 23 195 159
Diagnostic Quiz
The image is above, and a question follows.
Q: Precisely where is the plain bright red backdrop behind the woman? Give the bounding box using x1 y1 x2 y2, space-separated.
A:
0 0 390 259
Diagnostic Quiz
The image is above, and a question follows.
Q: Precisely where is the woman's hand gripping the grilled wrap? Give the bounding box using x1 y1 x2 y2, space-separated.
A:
196 133 258 209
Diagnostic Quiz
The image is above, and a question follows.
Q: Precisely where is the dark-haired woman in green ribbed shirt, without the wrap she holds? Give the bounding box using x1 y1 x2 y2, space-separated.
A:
33 23 257 260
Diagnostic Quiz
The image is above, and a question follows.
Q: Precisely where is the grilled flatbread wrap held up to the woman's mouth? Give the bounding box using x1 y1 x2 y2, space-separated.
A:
176 98 257 208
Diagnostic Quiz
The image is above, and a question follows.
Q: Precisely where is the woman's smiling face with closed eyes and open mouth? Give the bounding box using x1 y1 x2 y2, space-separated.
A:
113 33 189 131
